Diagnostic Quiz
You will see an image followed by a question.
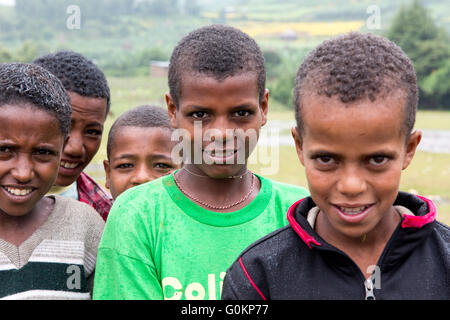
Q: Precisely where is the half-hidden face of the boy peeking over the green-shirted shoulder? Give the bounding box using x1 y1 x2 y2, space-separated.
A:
103 127 180 199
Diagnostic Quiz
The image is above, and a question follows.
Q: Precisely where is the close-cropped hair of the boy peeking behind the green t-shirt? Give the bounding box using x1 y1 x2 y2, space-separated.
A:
106 105 174 158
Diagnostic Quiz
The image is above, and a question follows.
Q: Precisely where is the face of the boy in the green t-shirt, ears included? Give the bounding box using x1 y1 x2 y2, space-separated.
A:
166 72 269 178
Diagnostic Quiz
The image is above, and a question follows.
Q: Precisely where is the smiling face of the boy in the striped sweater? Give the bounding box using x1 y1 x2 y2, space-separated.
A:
0 105 64 216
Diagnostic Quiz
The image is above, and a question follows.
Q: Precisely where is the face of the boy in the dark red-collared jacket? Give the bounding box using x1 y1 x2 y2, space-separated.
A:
292 95 421 237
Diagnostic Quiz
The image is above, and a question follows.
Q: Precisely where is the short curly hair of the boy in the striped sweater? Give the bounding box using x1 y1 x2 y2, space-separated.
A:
0 63 72 137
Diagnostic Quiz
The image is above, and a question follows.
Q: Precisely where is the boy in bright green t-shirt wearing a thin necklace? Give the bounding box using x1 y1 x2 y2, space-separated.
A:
94 25 308 300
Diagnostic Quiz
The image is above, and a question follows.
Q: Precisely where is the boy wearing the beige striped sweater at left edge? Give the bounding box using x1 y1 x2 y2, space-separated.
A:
0 64 104 300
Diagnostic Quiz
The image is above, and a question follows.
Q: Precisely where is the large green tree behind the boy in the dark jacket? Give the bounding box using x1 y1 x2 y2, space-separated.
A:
386 0 450 108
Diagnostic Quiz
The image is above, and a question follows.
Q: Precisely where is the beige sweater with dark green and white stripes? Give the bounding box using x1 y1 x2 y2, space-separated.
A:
0 195 104 300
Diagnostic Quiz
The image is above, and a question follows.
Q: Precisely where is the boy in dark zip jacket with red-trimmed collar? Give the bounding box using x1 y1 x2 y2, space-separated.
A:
222 33 450 300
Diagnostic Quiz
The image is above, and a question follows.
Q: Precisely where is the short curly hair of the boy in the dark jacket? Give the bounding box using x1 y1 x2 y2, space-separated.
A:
294 32 418 136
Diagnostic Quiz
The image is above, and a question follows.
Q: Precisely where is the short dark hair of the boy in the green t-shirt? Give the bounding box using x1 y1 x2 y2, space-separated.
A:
169 24 266 108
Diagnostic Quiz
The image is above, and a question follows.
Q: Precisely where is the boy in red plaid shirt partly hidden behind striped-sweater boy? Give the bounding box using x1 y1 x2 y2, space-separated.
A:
33 51 112 220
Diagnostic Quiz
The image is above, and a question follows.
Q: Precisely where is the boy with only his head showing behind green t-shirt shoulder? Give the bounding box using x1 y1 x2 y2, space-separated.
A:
103 105 181 199
